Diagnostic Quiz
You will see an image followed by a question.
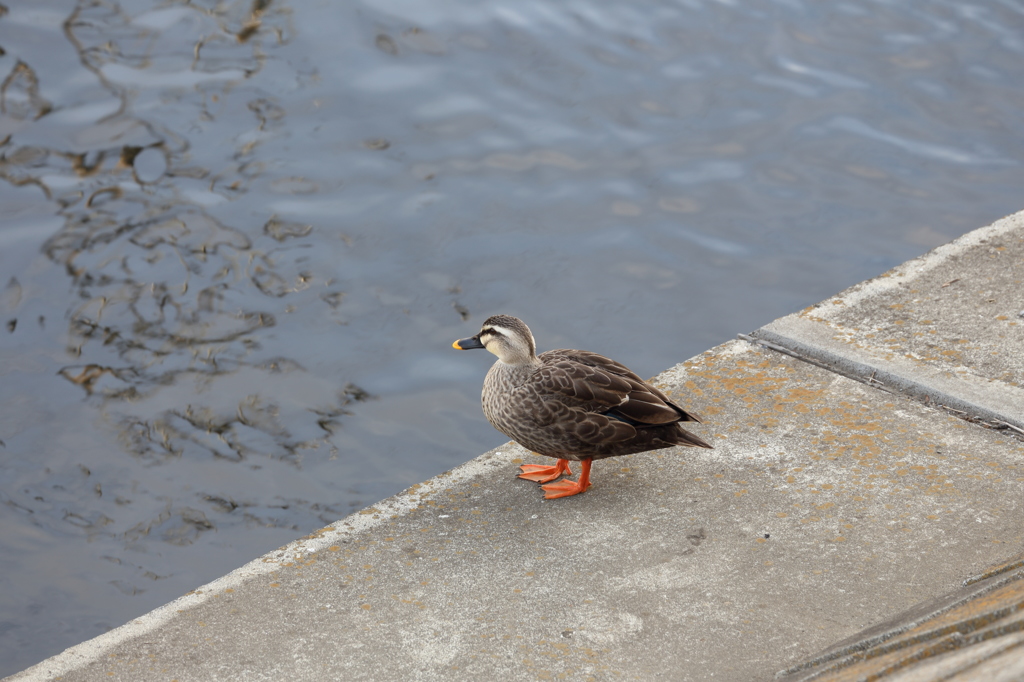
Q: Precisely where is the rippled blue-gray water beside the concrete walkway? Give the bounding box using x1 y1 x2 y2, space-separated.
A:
0 0 1024 675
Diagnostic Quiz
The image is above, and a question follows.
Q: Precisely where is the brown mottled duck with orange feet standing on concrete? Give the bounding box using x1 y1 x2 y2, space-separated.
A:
452 314 712 500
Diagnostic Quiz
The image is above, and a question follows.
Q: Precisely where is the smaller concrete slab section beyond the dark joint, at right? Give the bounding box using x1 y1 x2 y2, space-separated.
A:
754 212 1024 429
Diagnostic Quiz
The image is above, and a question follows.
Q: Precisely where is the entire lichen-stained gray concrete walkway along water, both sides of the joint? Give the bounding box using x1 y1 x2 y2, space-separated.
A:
9 213 1024 682
